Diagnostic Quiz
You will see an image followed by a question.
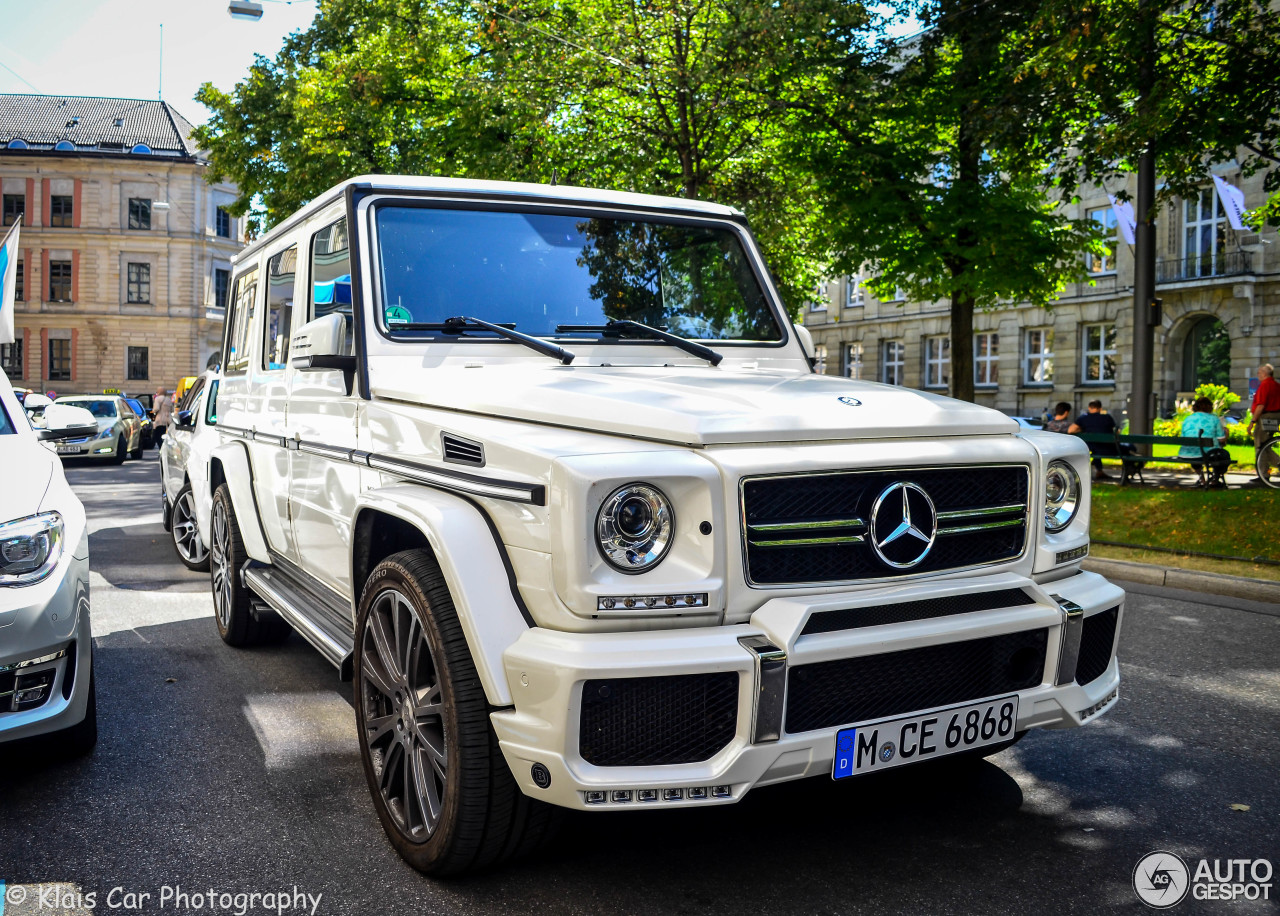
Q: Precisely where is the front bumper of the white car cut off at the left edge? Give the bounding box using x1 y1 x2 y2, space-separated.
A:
0 550 92 745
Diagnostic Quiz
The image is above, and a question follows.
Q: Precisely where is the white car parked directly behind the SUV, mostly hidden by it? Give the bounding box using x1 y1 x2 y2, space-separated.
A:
160 372 221 572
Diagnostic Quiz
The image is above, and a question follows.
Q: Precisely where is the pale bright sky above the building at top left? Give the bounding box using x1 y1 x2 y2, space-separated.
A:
0 0 316 124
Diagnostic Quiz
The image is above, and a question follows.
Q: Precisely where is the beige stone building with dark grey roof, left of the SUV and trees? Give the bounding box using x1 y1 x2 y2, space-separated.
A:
0 95 243 395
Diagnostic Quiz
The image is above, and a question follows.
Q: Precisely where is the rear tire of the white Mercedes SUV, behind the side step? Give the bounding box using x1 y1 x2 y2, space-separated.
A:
209 484 289 647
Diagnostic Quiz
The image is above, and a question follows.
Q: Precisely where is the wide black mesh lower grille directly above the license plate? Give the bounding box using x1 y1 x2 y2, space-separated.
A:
786 629 1048 733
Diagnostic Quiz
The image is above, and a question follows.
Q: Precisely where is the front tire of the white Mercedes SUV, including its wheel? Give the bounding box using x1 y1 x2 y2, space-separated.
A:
353 550 561 875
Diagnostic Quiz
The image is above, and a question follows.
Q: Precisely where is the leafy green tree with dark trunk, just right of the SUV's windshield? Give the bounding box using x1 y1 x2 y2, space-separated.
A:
790 0 1098 400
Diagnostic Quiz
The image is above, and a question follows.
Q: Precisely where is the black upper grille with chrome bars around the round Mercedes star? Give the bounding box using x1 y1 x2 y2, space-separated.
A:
742 464 1029 585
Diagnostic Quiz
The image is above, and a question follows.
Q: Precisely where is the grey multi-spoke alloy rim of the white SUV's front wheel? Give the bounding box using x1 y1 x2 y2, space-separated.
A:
360 588 449 843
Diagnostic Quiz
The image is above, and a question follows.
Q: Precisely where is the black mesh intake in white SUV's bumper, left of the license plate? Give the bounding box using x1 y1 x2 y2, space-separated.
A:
577 672 739 766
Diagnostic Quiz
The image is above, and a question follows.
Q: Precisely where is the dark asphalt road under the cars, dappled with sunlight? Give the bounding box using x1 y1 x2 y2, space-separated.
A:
0 452 1280 916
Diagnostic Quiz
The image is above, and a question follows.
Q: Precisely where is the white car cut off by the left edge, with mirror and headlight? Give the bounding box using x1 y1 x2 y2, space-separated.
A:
0 376 97 754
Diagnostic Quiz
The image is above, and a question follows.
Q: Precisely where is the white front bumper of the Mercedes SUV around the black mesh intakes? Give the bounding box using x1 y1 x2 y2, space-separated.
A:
492 572 1124 810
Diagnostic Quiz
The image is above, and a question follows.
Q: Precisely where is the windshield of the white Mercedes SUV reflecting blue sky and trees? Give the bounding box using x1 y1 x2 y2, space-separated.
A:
376 206 782 342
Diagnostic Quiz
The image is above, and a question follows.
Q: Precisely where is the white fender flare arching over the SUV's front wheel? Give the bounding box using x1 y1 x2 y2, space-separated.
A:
352 485 531 706
